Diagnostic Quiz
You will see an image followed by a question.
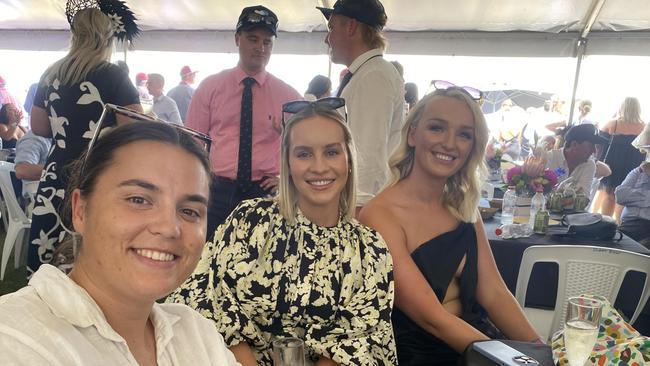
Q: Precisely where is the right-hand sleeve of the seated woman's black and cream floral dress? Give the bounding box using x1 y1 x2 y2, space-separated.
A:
305 224 397 366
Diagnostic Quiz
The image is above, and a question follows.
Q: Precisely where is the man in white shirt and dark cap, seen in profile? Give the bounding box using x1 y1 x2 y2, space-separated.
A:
318 0 404 209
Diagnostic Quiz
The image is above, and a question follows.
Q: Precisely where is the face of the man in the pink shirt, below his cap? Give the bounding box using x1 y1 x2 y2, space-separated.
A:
235 27 275 75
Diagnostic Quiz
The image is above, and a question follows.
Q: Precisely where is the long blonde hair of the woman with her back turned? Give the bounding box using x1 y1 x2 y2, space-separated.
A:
43 9 114 85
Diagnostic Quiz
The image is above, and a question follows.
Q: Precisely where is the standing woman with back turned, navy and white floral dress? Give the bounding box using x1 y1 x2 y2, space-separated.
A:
27 8 142 273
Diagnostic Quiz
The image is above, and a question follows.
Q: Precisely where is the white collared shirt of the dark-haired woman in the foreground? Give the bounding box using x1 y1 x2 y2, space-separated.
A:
0 265 239 366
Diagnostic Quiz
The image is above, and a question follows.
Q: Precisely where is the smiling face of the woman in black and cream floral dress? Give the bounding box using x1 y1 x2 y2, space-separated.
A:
289 115 349 223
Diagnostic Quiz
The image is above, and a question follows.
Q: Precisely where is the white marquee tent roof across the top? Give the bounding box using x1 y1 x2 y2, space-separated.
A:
0 0 650 57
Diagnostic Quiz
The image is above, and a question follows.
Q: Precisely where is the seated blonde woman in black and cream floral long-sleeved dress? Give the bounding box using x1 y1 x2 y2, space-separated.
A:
167 98 397 366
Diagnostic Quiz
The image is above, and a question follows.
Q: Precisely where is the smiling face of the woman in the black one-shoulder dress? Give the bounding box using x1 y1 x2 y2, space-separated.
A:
408 96 475 180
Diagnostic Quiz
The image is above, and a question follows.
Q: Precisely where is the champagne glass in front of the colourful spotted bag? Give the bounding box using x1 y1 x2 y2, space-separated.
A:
564 297 603 366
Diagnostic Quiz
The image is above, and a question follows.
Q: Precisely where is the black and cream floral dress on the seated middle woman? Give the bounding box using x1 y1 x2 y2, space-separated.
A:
167 199 397 366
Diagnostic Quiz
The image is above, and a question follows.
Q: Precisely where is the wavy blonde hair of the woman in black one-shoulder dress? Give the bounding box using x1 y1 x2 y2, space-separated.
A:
388 87 489 222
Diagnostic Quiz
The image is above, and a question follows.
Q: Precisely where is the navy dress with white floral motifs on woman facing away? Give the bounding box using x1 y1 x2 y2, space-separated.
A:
27 63 140 273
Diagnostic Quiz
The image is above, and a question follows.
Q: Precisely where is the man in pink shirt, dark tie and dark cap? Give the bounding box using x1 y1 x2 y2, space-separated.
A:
185 5 302 234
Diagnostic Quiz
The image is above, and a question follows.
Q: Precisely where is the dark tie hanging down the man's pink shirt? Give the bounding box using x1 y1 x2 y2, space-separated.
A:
237 77 255 191
